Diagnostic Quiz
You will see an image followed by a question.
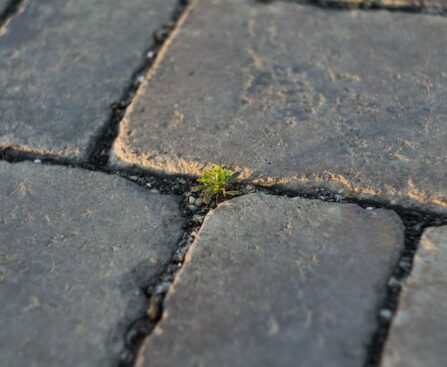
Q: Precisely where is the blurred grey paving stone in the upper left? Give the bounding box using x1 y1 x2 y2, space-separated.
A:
0 0 178 160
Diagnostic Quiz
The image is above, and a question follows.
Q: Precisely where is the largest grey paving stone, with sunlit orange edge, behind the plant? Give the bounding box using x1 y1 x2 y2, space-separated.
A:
114 0 447 211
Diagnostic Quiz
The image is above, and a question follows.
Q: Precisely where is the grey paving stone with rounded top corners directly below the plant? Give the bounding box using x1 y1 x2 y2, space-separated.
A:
137 194 403 367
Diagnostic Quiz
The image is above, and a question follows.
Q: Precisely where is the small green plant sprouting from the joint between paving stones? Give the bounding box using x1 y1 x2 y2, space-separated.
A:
196 166 239 204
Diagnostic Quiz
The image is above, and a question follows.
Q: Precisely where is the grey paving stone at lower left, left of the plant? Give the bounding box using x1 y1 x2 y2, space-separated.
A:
0 162 182 367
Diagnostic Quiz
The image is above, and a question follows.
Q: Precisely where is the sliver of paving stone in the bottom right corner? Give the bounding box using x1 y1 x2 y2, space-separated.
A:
382 226 447 367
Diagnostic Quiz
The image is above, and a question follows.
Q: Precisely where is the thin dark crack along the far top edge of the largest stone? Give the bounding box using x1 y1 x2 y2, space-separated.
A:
257 0 447 16
